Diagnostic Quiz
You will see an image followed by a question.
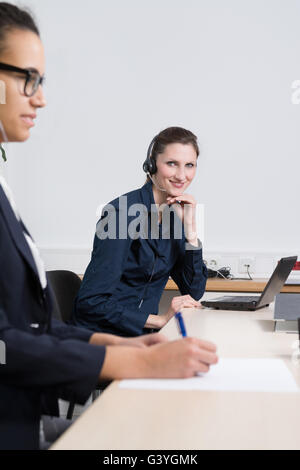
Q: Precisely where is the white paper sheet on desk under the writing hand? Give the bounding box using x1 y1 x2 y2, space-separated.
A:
119 359 299 392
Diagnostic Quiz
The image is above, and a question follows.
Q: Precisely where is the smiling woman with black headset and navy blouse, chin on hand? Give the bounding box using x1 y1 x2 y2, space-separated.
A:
73 127 207 336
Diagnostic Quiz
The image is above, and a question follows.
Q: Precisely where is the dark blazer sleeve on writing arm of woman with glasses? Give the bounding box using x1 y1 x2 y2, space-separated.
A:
0 305 105 404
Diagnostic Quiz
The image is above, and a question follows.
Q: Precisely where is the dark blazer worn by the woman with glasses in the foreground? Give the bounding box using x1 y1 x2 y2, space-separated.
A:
0 185 105 449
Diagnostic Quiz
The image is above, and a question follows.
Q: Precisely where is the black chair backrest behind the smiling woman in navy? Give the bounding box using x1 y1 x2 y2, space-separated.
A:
47 270 81 323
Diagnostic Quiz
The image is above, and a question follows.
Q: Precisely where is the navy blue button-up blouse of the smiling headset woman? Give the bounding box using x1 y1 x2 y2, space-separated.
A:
72 182 207 336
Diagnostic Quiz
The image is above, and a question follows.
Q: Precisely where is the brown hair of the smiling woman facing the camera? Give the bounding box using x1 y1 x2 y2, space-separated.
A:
147 127 200 181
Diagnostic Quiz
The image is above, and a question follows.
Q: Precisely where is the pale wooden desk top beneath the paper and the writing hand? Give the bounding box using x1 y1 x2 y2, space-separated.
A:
52 293 300 450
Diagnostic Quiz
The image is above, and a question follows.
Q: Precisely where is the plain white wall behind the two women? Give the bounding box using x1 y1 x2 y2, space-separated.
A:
2 0 300 271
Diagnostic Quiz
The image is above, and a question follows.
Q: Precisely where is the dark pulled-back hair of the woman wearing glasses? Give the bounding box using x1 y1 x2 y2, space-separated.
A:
0 2 40 52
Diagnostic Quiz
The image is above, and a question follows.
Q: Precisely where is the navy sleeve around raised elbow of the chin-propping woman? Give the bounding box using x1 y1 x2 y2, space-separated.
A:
171 240 207 300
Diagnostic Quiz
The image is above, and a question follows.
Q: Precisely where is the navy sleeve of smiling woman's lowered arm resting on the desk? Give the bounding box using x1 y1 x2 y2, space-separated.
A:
74 205 148 336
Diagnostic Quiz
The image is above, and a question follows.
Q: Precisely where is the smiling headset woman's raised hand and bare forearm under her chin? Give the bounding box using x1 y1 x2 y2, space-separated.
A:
167 194 198 246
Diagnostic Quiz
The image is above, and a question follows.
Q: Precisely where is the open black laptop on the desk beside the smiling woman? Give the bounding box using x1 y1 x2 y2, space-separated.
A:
201 256 297 310
